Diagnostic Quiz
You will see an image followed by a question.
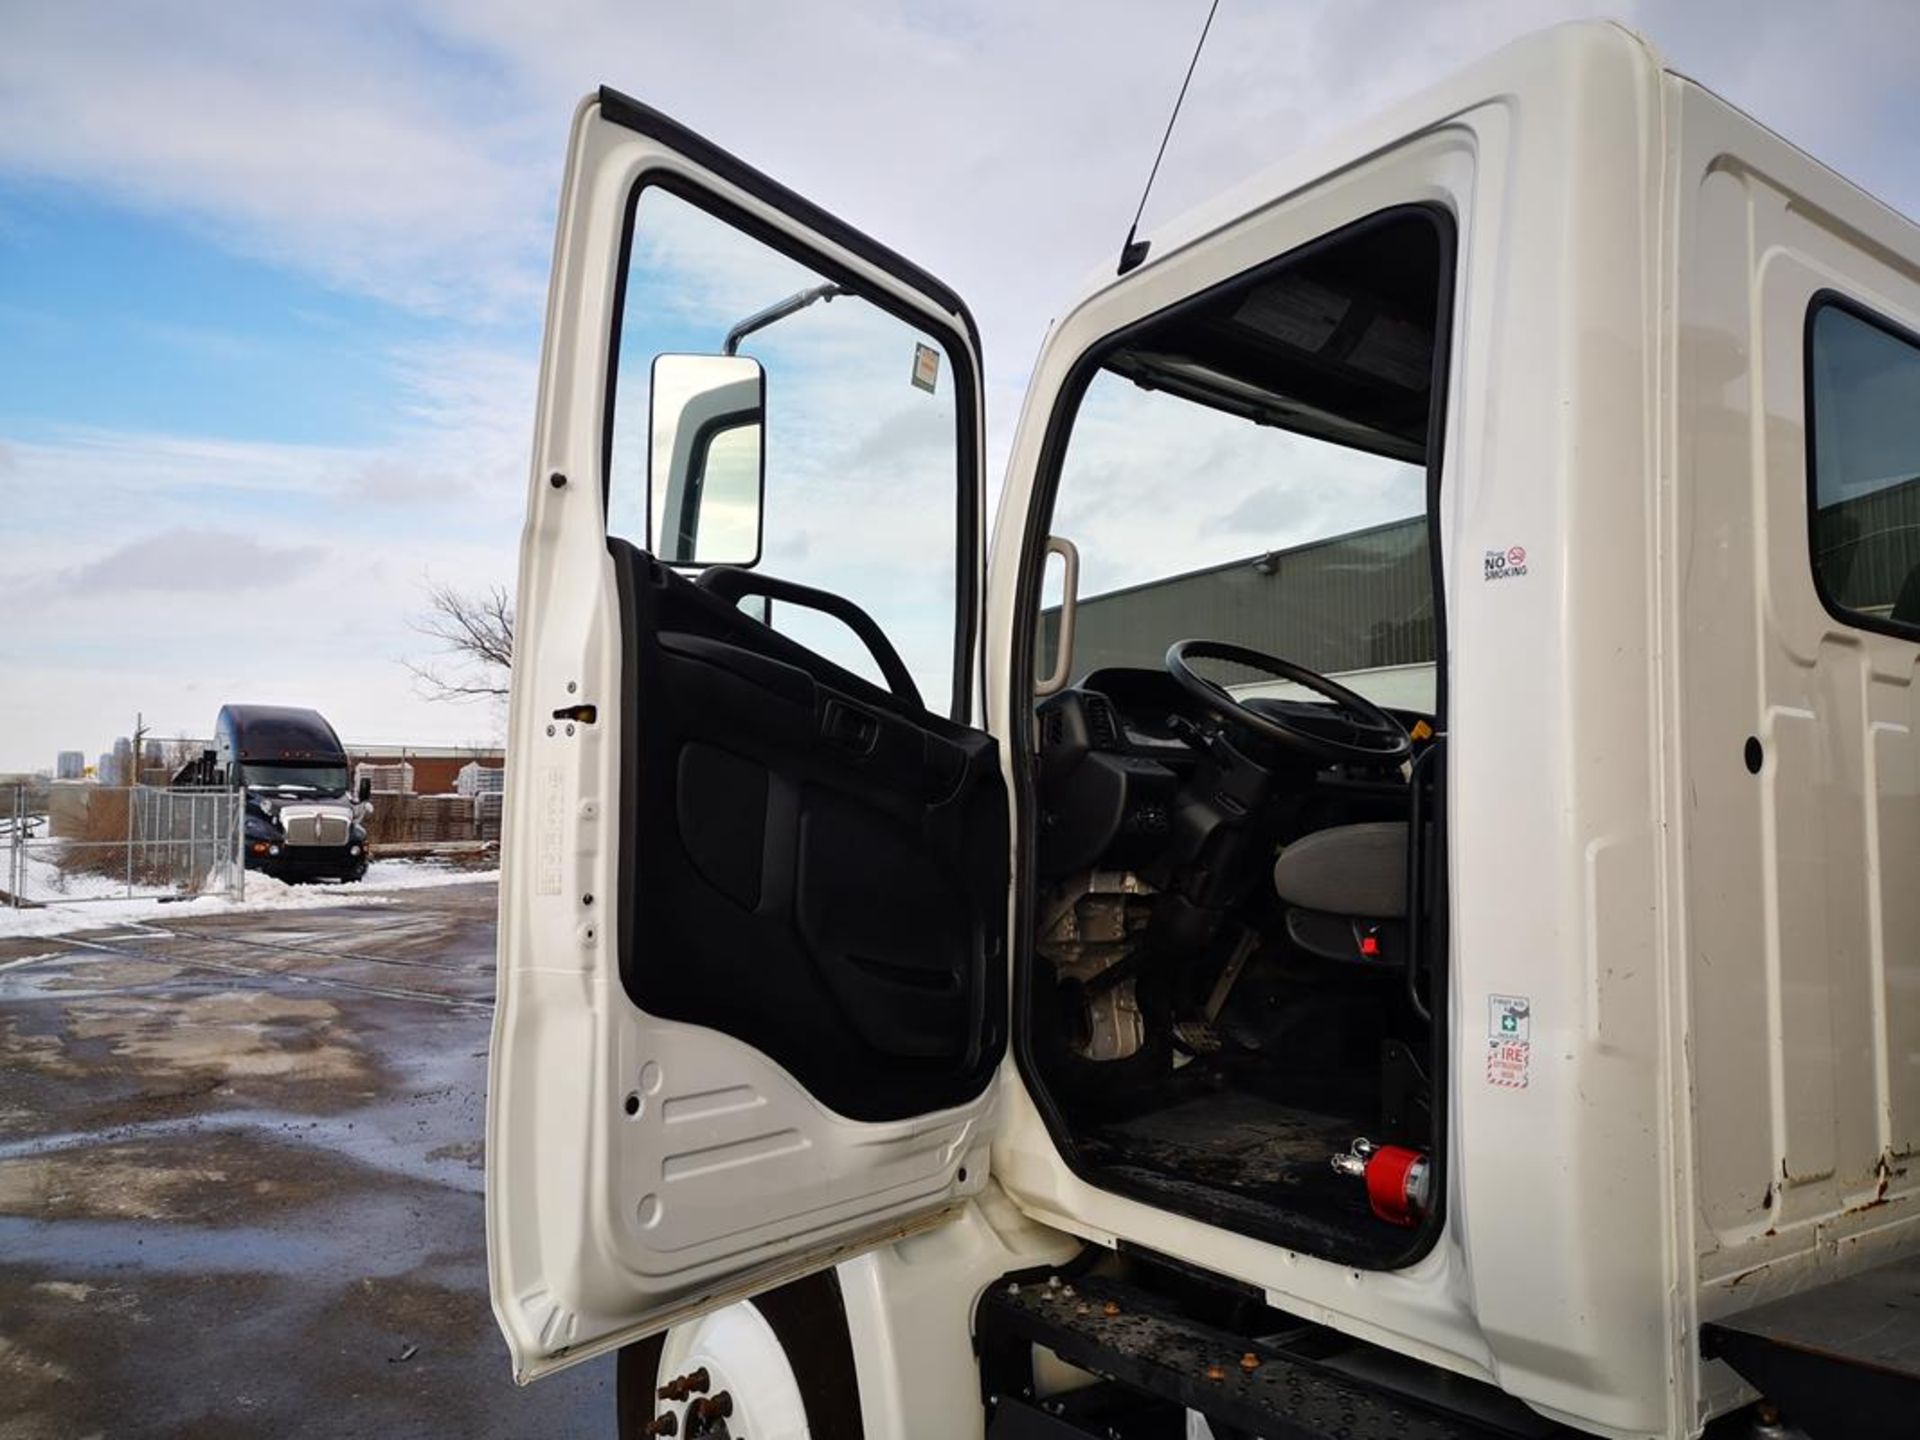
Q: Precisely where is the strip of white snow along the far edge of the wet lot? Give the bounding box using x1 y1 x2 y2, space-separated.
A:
0 860 499 939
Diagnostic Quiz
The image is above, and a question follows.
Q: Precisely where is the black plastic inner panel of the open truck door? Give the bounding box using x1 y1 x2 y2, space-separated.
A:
609 540 1008 1119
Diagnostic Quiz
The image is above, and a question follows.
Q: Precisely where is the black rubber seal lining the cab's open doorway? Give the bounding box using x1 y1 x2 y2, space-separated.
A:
1006 202 1459 1271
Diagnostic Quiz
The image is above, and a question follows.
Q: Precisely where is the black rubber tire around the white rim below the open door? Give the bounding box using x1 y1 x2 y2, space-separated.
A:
614 1269 866 1440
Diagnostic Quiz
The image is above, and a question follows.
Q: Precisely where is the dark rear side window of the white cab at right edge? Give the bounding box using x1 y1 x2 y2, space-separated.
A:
1807 298 1920 636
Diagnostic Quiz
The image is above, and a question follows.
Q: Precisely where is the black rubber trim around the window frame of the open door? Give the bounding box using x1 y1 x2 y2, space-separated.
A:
599 84 987 724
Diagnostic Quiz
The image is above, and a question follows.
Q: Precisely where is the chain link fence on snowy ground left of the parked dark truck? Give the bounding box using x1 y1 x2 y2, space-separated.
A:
0 781 246 906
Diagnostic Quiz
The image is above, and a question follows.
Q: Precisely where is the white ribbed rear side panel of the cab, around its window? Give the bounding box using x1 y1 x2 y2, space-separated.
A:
1676 83 1920 1344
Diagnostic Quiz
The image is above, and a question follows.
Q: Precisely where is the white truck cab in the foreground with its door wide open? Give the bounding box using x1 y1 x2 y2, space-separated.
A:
488 23 1920 1440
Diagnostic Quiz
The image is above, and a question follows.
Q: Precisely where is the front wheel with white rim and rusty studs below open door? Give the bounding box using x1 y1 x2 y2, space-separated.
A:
618 1271 862 1440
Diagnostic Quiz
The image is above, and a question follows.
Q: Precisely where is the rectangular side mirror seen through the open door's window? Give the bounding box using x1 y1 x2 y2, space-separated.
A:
647 355 766 566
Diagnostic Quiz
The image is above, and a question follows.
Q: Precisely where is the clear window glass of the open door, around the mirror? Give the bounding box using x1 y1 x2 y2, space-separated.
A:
607 184 972 712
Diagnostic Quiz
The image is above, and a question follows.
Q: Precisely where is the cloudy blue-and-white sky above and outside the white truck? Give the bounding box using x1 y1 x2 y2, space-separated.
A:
0 0 1920 768
